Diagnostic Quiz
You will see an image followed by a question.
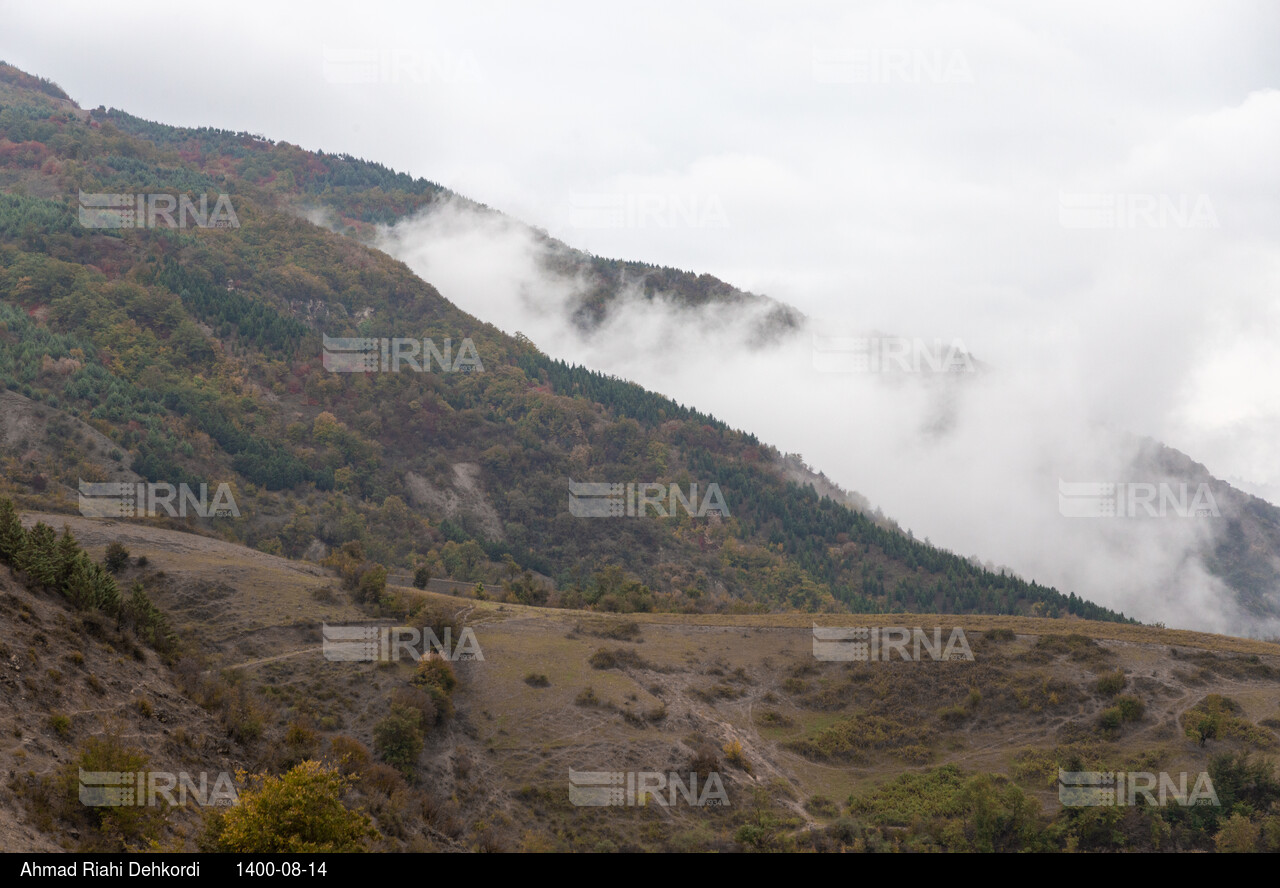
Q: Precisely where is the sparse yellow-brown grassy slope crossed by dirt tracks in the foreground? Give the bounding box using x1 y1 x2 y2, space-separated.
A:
10 516 1280 850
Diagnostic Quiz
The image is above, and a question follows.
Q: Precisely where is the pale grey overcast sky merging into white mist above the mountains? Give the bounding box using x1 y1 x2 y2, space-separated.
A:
0 0 1280 629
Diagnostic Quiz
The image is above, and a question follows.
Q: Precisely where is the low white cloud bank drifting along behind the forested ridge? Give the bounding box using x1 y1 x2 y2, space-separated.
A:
379 149 1275 633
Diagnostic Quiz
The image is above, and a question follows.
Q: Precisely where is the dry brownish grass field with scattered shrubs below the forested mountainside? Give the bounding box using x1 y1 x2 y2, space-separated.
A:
0 514 1280 850
